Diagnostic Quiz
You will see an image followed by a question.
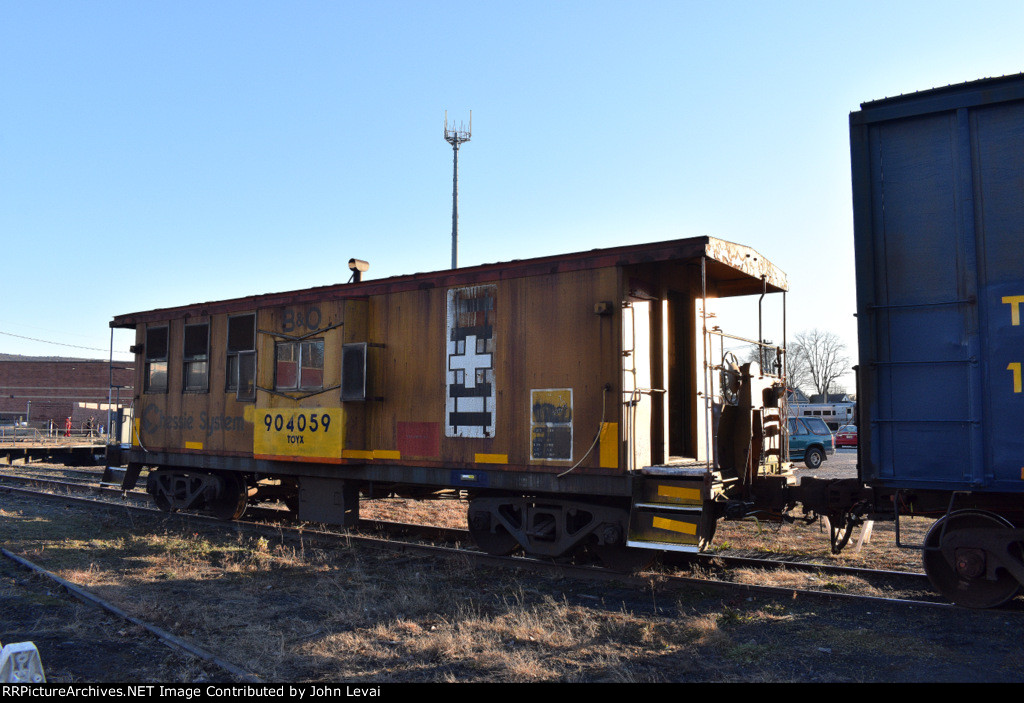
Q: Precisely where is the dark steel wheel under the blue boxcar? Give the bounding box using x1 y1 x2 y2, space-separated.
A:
924 511 1020 608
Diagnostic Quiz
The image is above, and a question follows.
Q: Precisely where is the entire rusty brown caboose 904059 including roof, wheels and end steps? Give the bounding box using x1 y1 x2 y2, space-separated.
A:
112 237 792 567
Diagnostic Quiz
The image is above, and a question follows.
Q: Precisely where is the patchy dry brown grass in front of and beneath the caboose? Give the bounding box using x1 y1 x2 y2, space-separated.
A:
0 489 1024 683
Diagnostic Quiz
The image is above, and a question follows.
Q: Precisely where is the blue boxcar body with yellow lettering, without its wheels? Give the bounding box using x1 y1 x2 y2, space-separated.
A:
850 75 1024 493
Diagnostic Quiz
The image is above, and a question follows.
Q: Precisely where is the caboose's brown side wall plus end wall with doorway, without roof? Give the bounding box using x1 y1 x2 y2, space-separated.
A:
125 258 720 476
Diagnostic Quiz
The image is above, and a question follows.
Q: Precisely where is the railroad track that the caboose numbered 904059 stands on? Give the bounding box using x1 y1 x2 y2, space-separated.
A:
0 476 991 611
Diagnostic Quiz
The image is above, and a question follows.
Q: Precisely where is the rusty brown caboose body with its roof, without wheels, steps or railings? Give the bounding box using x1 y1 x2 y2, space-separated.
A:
112 237 785 505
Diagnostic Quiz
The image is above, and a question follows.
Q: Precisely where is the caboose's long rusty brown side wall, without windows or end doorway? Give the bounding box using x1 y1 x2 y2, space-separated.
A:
130 267 621 472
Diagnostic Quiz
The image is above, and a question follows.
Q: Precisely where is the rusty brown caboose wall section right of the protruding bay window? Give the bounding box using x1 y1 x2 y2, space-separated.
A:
366 268 618 472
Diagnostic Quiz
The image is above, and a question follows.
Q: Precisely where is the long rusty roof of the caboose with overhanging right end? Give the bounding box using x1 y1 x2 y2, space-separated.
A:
111 236 788 329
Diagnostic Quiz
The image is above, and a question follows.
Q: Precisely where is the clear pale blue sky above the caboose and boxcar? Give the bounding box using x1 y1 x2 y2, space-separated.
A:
0 0 1024 390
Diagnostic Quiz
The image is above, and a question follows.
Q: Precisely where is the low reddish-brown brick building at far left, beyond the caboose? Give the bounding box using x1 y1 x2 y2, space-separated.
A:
0 354 135 430
